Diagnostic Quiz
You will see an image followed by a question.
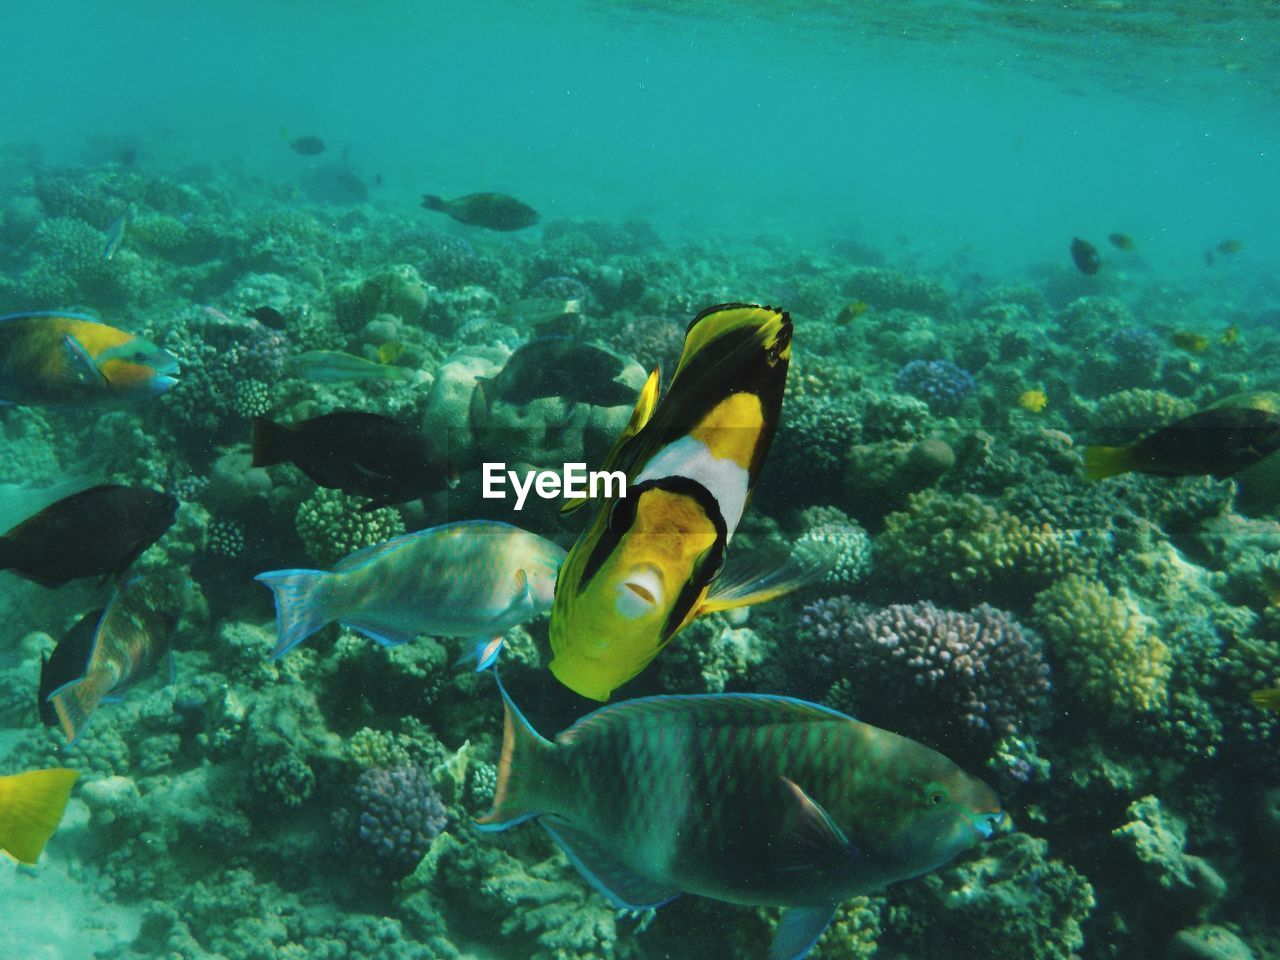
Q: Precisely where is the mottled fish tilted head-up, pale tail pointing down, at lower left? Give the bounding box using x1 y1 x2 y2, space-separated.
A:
41 579 178 742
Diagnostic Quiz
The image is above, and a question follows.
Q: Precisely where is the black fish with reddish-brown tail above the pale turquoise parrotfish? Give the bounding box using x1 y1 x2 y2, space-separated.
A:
253 412 453 511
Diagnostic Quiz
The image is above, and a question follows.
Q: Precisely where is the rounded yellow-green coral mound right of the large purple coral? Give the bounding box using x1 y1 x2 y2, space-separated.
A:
1036 575 1172 714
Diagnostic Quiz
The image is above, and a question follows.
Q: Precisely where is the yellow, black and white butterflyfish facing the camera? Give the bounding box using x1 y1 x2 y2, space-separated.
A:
550 303 814 700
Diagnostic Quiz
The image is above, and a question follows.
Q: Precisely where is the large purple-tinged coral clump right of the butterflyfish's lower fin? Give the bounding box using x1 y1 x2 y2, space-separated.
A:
801 596 1050 753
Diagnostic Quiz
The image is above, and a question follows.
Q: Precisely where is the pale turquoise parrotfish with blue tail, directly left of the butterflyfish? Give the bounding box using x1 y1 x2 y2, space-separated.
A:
255 520 564 667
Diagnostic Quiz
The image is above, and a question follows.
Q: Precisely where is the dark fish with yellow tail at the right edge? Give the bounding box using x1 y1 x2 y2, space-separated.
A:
1084 407 1280 480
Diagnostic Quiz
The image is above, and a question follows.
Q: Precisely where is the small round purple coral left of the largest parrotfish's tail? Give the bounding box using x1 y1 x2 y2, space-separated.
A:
356 767 448 876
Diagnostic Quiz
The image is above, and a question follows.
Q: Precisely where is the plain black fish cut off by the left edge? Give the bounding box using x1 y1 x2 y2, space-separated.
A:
0 484 178 588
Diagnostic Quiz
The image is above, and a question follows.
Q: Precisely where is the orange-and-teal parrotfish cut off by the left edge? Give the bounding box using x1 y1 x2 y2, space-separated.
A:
0 312 178 406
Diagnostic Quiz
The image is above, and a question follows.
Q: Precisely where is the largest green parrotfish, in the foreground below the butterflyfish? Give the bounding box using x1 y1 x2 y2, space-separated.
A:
479 690 1009 960
